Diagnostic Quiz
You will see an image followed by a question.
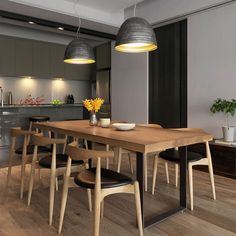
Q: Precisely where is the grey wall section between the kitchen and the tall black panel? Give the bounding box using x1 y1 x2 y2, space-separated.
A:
111 42 148 123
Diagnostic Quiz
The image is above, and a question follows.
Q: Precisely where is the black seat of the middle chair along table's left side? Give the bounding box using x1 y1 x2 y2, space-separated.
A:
39 154 84 169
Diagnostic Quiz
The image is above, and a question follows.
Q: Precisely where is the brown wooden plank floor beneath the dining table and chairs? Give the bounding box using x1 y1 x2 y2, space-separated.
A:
0 154 236 236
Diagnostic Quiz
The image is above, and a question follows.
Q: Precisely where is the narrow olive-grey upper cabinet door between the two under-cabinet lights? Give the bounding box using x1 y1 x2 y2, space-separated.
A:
33 41 50 79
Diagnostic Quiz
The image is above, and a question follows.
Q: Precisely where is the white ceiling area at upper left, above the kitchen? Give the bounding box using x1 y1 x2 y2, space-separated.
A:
6 0 143 28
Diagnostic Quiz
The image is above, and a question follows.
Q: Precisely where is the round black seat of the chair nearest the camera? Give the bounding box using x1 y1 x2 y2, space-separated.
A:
74 168 133 189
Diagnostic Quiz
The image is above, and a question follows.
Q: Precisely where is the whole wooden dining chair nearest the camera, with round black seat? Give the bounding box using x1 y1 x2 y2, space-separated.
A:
58 143 143 236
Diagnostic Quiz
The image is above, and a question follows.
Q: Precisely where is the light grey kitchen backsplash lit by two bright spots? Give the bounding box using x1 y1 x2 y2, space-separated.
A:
0 77 91 104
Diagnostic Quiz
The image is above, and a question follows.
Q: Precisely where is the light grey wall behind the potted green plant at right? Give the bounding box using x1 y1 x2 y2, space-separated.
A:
188 3 236 137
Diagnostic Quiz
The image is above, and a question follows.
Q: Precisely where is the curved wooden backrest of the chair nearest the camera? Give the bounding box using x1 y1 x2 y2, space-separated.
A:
67 142 114 161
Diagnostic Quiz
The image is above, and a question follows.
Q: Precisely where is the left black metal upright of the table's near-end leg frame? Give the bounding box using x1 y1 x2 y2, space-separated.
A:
136 152 144 225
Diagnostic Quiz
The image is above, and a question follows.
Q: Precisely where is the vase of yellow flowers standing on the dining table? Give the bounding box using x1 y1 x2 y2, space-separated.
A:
83 98 104 126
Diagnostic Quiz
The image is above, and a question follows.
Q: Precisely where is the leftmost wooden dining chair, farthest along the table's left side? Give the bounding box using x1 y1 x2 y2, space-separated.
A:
6 127 50 199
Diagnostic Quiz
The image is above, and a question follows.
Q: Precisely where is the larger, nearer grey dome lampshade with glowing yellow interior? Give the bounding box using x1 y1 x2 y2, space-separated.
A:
115 17 157 53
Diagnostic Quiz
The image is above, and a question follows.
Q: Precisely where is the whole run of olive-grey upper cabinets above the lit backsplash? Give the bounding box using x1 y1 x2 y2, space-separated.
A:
0 36 92 80
